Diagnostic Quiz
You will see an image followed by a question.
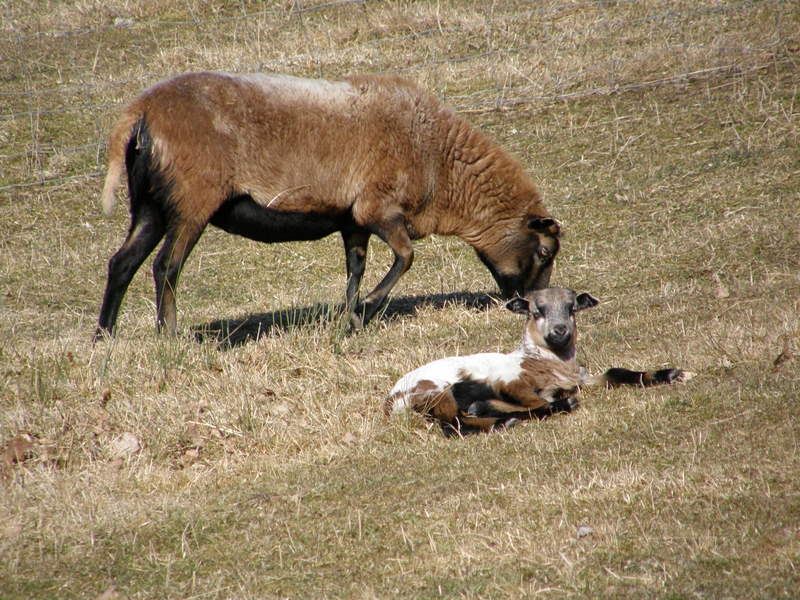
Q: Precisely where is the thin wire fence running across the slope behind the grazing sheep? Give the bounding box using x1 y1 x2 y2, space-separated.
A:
0 0 800 191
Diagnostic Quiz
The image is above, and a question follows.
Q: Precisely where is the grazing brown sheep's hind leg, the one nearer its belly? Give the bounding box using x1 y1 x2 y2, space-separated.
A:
153 223 204 335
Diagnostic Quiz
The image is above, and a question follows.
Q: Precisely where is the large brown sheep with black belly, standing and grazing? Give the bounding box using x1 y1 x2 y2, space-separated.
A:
96 73 560 337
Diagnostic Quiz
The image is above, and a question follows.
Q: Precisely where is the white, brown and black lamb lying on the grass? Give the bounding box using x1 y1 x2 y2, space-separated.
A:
384 288 693 434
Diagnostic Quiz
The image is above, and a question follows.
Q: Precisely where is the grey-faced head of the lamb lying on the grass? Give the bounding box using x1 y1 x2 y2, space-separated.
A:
506 288 600 360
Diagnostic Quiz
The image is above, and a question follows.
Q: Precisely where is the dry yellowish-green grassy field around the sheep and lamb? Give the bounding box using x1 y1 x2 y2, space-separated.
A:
0 1 800 599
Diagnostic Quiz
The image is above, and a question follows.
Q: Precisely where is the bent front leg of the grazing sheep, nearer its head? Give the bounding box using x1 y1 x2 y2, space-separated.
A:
350 213 414 329
